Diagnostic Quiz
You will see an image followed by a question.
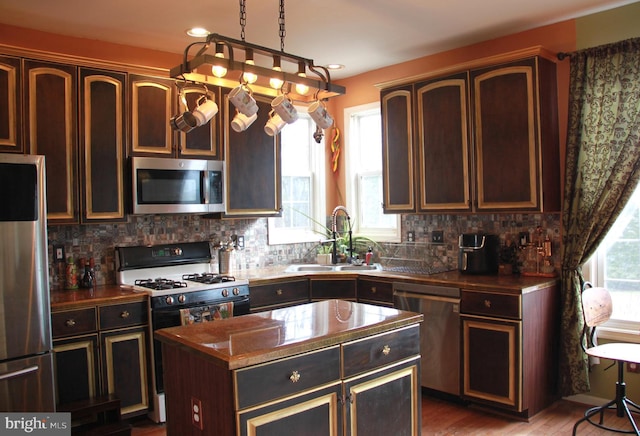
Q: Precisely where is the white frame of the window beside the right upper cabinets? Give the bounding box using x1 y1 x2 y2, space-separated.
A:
344 101 402 242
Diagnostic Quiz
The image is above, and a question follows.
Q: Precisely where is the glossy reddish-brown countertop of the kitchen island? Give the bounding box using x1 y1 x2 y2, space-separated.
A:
154 300 423 370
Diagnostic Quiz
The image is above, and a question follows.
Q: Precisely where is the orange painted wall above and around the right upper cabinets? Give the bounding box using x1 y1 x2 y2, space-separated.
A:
327 20 576 210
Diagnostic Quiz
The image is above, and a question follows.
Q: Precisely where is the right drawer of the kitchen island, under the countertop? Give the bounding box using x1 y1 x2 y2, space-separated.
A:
342 324 420 378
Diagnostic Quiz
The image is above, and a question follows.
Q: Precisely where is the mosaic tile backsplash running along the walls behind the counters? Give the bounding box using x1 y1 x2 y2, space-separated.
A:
48 214 561 289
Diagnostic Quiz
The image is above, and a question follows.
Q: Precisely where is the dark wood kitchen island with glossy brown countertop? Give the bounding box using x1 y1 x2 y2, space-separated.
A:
155 300 422 436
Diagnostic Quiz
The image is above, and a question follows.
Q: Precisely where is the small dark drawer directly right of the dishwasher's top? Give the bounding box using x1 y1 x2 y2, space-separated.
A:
460 290 522 319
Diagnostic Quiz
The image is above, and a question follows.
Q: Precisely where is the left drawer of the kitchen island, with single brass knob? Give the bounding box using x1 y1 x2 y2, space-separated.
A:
234 346 340 410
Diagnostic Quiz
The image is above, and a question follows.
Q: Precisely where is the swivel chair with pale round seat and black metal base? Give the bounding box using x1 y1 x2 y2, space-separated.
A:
573 282 640 436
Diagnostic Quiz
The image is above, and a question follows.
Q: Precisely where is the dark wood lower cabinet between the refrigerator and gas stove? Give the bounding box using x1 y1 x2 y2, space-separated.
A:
51 301 149 418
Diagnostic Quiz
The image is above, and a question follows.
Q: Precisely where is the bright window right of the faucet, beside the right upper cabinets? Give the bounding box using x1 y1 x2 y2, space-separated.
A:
345 103 400 242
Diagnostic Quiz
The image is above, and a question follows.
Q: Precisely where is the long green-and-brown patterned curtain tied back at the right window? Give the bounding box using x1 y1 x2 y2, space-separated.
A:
559 38 640 396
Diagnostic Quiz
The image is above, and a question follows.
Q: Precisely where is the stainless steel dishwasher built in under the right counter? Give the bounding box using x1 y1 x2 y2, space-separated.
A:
393 282 460 396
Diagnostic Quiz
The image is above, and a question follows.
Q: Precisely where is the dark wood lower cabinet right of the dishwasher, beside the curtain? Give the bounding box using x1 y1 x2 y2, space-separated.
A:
460 284 560 419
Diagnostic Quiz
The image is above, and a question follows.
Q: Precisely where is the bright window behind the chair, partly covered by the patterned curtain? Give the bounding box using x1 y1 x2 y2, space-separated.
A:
583 182 640 335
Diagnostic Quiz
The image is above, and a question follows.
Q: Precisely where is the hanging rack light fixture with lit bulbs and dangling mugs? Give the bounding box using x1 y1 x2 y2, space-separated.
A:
170 0 345 137
